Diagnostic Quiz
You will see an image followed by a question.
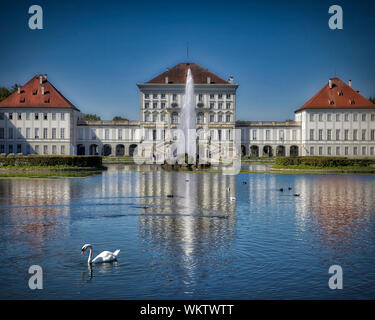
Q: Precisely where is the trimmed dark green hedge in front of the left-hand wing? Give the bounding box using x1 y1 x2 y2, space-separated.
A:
0 155 102 168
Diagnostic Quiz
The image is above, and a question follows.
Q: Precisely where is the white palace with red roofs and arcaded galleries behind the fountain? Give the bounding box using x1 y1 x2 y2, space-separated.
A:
0 63 375 157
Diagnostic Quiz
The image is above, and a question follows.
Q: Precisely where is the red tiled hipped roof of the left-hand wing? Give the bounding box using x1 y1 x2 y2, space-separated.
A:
0 74 79 111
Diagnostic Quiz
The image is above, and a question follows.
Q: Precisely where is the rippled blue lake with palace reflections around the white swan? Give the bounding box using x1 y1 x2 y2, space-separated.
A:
0 165 375 299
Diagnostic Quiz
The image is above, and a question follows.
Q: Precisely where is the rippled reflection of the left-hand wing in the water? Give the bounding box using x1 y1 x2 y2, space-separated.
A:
0 179 73 249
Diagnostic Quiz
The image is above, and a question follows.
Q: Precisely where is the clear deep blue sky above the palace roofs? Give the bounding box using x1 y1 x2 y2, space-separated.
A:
0 0 375 121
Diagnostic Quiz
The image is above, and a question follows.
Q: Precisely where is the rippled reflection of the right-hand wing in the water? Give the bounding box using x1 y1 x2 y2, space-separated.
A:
296 175 375 246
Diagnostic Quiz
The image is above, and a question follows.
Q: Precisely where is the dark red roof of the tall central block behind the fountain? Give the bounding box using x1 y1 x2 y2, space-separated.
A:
147 62 229 84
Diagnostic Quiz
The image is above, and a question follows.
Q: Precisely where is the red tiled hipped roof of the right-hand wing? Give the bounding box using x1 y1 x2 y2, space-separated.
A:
295 78 375 112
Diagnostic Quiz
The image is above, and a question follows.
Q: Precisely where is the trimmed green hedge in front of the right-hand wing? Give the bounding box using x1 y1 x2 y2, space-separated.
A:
275 157 374 167
